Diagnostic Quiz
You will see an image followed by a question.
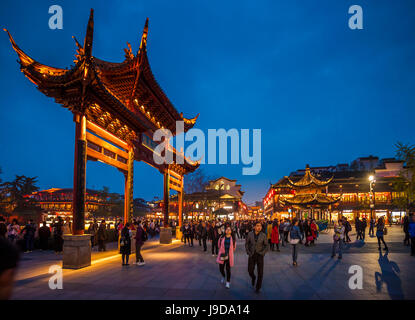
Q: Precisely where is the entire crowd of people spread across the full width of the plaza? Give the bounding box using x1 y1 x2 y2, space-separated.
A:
0 213 415 298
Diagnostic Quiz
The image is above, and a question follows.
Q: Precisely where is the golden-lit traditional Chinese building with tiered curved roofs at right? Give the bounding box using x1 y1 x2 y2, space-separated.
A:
263 156 405 222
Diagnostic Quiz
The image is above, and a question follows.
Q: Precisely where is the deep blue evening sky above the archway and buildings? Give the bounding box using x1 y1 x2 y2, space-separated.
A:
0 0 415 202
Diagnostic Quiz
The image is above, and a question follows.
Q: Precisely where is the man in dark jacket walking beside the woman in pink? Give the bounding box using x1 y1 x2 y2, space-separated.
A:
245 222 268 293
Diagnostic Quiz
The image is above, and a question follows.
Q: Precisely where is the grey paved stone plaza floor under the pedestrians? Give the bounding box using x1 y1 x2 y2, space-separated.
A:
12 227 415 300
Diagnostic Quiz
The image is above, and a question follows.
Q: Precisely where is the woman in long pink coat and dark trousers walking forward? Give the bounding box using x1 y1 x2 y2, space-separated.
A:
216 226 236 289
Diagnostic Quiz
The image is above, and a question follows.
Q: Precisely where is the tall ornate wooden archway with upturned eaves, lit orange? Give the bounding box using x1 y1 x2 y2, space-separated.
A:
5 9 199 260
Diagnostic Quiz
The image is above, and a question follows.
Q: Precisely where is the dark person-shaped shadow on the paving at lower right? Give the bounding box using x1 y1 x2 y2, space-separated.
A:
375 251 404 300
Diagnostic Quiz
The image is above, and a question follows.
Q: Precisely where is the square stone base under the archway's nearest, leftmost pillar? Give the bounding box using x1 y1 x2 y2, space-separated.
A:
62 234 91 269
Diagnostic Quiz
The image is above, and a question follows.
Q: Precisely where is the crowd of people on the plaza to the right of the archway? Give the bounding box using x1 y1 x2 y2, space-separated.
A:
175 213 415 292
